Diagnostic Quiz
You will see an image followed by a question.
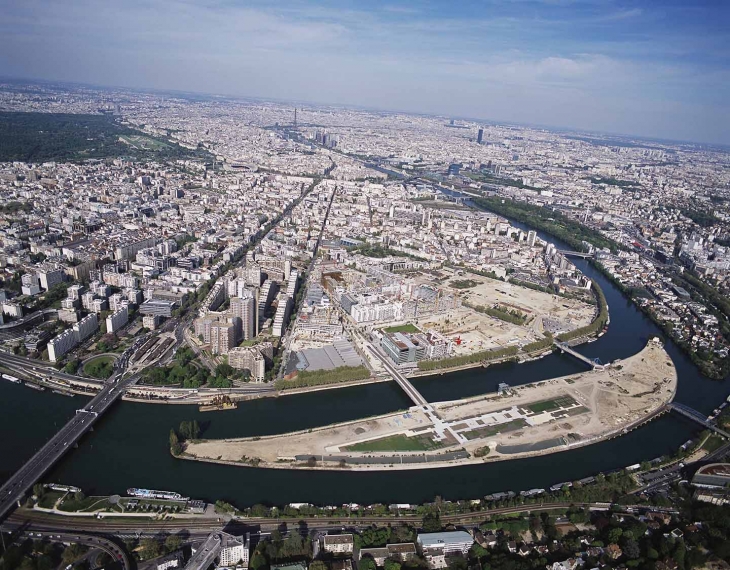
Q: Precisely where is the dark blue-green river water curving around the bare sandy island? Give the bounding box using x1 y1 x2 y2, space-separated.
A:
0 217 730 507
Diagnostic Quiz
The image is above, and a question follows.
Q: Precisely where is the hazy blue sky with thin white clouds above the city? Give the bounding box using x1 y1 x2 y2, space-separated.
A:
0 0 730 144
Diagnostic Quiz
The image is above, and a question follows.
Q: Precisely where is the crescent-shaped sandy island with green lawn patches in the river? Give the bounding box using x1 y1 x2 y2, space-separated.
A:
181 340 677 471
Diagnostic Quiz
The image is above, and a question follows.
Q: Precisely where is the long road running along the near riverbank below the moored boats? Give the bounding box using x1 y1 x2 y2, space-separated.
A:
2 502 674 538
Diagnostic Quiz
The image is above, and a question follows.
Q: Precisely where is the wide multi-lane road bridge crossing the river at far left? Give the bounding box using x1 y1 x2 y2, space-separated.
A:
0 375 138 520
